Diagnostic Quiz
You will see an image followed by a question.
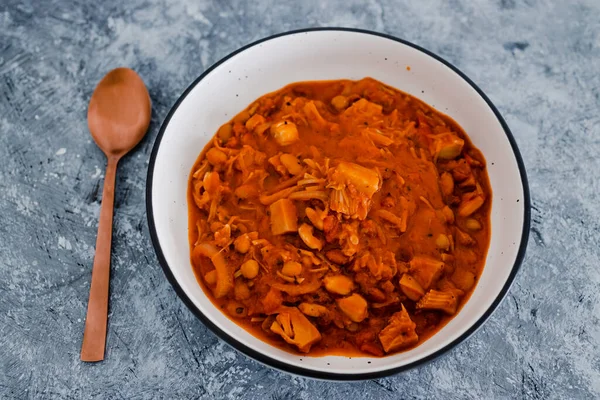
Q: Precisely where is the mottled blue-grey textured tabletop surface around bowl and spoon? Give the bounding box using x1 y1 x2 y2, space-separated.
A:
0 0 600 400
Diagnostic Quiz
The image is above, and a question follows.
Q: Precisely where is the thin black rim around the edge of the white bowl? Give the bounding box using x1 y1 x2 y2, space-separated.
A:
146 27 531 381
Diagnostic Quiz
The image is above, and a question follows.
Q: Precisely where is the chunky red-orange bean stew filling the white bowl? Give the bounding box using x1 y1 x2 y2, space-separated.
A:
189 78 492 356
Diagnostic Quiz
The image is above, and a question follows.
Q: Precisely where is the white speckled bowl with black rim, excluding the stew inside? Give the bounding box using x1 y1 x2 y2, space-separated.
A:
146 28 530 380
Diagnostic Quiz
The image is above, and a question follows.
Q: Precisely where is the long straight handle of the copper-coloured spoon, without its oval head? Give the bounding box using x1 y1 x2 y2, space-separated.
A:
81 156 119 362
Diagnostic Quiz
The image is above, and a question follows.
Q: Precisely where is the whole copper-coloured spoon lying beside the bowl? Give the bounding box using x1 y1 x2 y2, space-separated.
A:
81 68 152 361
